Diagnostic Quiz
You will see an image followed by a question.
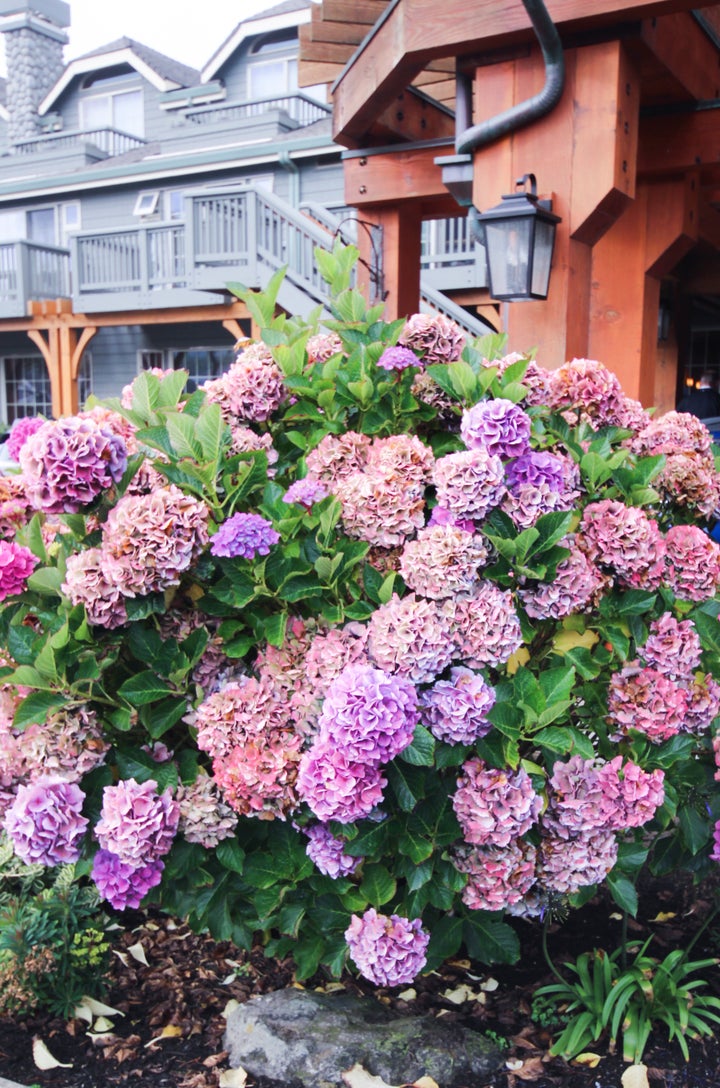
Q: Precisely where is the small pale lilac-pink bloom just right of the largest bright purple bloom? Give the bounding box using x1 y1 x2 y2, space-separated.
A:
420 668 495 744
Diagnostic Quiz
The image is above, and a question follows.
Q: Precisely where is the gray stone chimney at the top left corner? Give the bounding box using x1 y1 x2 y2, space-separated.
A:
0 0 70 149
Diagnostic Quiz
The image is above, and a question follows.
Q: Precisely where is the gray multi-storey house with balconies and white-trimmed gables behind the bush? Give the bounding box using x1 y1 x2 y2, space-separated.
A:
0 0 484 423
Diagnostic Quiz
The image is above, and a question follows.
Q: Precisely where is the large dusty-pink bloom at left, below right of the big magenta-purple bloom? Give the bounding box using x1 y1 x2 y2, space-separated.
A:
101 484 209 597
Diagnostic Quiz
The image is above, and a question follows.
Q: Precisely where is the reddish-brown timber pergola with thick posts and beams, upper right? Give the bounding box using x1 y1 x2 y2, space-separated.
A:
300 0 720 409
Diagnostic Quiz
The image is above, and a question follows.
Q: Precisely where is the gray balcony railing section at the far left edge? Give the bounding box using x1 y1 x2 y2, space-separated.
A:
0 242 70 318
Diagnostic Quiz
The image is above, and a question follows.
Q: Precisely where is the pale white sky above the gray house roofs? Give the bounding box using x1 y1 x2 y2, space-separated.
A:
0 0 277 75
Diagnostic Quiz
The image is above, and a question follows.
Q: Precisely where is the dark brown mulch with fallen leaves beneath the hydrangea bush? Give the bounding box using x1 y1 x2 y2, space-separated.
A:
0 887 720 1088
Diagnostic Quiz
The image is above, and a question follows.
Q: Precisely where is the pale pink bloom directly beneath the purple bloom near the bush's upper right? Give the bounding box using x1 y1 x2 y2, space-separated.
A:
433 449 506 521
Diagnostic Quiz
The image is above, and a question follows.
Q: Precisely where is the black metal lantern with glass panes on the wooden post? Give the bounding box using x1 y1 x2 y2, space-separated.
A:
474 174 560 302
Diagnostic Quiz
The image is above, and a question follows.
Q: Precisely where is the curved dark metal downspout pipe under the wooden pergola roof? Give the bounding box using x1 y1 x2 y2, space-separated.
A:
455 0 564 154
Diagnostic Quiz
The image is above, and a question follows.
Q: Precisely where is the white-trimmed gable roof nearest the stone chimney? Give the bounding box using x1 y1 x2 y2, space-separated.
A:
38 38 200 116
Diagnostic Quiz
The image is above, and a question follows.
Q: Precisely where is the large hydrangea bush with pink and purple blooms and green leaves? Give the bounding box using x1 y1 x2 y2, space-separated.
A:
0 248 720 986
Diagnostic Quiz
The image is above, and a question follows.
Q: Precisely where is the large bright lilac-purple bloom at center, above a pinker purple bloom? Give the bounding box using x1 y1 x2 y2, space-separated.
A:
318 665 420 766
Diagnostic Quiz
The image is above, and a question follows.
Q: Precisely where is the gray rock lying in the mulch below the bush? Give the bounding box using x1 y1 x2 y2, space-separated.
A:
224 989 502 1088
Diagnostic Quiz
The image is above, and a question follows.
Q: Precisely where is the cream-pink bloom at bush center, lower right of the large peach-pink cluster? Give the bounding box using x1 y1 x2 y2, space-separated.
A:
400 524 489 601
